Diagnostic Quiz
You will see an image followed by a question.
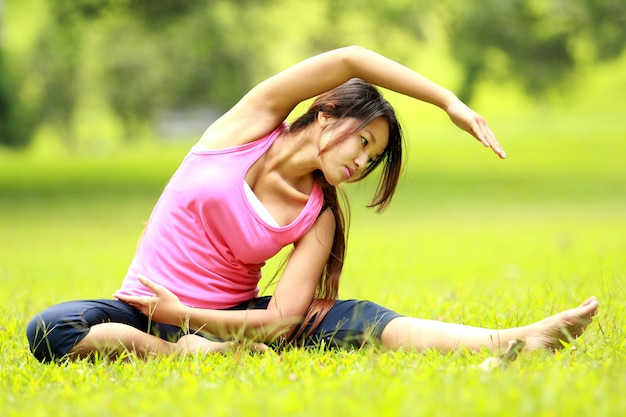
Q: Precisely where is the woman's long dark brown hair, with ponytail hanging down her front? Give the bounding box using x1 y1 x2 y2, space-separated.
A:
289 78 403 341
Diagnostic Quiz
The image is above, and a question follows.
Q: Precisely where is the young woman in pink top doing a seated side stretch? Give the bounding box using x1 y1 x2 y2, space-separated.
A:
27 47 598 361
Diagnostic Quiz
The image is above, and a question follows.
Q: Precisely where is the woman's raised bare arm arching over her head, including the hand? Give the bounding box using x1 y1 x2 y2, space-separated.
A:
202 46 506 158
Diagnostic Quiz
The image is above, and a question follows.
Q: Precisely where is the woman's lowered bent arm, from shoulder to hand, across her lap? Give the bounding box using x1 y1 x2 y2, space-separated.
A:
115 210 335 342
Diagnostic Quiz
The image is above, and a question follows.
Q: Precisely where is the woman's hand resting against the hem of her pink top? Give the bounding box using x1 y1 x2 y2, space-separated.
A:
115 275 186 326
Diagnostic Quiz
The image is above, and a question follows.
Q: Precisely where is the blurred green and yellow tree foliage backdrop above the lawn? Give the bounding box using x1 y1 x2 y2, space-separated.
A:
0 0 626 151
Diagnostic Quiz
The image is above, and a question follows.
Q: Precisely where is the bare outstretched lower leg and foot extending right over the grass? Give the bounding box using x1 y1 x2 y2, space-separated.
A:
381 297 598 351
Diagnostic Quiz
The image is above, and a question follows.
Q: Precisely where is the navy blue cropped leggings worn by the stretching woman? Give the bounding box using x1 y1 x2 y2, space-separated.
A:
26 296 400 362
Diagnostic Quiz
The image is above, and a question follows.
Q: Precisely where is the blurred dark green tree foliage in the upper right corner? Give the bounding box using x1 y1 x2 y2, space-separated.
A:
446 0 626 102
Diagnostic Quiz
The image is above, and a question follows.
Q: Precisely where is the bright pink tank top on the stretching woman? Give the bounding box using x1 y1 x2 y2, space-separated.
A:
114 124 324 309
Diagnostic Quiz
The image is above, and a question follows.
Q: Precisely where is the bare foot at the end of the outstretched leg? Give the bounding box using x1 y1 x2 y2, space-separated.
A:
526 297 598 351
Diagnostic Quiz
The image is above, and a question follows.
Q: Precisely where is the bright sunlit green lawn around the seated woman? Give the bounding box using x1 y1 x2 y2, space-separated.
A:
0 96 626 416
